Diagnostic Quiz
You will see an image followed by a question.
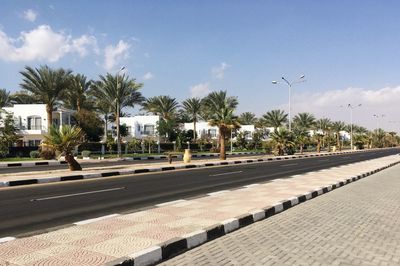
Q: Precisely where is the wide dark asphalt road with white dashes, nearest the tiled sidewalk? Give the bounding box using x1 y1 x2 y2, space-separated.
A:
0 149 399 237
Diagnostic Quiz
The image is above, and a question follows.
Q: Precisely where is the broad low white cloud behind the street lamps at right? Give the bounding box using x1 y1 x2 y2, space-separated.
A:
290 86 400 131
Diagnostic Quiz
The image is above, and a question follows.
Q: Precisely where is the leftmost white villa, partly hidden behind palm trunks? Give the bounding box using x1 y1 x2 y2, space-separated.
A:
3 104 75 146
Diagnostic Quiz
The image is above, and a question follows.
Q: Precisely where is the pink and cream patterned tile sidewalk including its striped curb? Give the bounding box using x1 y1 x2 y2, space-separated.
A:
0 155 400 266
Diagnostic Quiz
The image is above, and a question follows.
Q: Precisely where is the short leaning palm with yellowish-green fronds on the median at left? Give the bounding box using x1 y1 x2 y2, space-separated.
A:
43 125 84 171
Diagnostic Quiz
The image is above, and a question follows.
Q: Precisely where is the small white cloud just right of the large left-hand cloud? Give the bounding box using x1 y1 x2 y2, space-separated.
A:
103 40 131 71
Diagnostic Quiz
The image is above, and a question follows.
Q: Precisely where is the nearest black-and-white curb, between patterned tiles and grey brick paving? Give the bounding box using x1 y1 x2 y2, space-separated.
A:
106 162 400 266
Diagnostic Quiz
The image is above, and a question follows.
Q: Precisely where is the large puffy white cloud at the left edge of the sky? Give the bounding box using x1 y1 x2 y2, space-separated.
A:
0 25 98 62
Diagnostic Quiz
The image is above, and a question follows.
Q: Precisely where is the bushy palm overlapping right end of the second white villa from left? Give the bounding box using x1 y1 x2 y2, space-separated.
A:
142 95 179 138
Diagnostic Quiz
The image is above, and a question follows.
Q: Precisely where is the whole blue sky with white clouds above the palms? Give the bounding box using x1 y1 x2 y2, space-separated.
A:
0 0 400 131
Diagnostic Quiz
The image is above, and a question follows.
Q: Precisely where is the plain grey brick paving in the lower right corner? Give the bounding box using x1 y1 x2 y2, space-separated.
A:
162 160 400 266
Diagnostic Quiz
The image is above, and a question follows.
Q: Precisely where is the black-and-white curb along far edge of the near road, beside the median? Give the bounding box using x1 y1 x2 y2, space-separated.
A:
0 150 388 188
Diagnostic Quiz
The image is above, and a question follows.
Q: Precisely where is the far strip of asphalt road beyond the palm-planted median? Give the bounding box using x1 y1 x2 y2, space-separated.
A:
0 154 262 175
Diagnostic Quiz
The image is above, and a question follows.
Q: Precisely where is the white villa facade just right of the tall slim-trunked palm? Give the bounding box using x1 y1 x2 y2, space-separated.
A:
120 115 160 141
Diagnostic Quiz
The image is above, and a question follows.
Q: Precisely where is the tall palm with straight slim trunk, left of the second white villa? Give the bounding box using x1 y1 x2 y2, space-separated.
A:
91 73 144 155
